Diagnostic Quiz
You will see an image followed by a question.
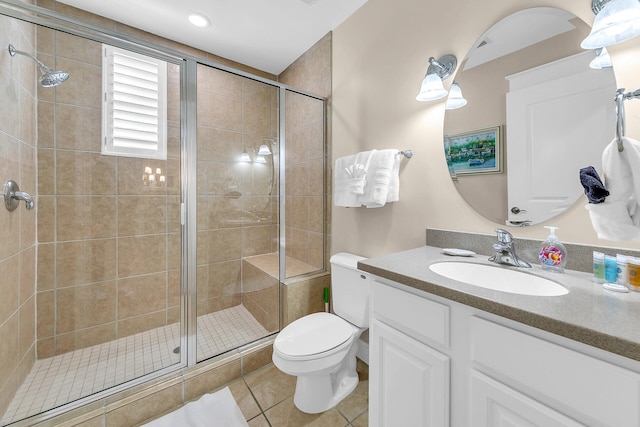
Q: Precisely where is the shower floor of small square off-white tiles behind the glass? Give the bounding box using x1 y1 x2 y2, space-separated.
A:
0 305 268 425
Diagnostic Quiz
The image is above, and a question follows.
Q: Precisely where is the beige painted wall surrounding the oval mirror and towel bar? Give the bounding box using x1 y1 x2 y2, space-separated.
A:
331 0 640 256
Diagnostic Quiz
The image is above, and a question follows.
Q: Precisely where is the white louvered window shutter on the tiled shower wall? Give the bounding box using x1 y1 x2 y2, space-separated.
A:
102 45 167 159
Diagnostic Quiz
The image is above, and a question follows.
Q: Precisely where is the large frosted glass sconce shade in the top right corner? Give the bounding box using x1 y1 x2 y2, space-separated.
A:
580 0 640 49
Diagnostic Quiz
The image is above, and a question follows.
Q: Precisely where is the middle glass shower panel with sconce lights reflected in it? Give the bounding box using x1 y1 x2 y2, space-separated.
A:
192 64 280 361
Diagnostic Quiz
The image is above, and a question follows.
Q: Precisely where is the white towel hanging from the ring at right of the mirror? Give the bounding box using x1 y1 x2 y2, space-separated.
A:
586 137 640 242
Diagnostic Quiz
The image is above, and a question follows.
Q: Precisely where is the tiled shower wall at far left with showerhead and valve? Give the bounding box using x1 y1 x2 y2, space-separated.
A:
0 16 38 414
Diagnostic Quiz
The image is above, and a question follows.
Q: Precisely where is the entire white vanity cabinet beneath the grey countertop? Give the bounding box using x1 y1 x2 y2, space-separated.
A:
369 282 640 427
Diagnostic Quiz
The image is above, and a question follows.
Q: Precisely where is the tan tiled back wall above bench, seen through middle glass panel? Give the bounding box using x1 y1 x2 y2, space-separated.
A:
192 65 278 320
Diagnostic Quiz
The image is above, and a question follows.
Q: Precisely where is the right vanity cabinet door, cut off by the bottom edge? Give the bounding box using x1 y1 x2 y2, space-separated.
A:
470 371 583 427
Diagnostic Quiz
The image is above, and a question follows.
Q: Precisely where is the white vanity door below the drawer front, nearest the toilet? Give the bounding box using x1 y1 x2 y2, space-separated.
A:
369 319 449 427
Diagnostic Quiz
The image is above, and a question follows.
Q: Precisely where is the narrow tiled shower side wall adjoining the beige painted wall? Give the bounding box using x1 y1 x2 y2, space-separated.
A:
278 33 331 277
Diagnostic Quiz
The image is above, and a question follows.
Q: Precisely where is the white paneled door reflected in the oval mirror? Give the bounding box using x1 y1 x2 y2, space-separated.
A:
505 54 616 224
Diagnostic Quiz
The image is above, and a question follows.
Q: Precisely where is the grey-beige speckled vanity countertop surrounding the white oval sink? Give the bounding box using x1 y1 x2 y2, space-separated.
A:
358 246 640 361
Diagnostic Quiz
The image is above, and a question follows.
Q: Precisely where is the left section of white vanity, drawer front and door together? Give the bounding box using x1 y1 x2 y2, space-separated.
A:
369 282 450 427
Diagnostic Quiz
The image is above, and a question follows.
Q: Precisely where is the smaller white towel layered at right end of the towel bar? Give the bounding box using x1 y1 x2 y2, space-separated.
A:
361 149 400 208
